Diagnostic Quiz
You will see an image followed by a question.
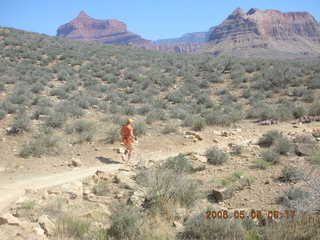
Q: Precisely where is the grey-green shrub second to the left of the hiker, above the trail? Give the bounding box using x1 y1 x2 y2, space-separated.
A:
66 119 96 143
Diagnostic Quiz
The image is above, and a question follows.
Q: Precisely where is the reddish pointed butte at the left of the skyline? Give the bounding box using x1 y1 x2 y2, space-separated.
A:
57 11 149 45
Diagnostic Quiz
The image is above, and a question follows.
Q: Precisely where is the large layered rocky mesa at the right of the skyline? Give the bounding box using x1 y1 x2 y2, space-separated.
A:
208 8 320 56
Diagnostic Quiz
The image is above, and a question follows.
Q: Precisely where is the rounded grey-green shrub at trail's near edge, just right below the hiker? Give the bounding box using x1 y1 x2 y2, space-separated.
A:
162 153 193 173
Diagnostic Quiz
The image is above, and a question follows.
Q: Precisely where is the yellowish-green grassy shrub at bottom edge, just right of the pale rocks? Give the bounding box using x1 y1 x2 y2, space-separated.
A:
56 214 90 240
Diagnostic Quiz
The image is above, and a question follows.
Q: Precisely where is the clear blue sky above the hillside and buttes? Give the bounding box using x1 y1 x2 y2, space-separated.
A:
0 0 320 40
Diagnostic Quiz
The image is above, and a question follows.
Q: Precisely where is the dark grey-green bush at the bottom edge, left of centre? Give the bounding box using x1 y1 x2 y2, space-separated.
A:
106 204 143 240
